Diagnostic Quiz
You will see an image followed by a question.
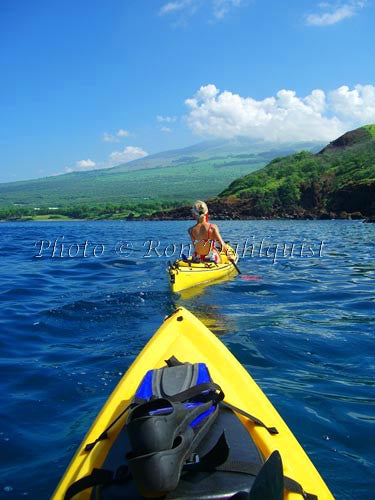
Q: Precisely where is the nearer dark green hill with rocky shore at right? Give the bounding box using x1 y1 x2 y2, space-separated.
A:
219 125 375 216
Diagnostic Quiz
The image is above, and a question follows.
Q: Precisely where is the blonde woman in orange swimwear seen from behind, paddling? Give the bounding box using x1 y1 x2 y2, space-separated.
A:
189 200 226 264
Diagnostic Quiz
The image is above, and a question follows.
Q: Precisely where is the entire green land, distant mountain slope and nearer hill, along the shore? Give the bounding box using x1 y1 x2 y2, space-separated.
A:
0 125 375 220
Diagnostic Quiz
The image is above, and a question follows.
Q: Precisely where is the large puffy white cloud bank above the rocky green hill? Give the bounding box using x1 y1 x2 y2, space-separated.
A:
185 84 375 142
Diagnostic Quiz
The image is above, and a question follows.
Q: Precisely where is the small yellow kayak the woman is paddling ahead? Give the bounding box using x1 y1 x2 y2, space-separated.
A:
168 245 238 292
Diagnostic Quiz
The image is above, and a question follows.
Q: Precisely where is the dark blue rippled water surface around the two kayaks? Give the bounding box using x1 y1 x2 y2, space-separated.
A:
0 221 375 499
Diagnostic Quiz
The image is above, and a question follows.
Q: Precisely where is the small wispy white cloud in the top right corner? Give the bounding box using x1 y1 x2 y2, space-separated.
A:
306 0 366 26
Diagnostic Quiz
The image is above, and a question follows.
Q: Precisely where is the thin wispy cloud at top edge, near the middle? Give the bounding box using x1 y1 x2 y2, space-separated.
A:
159 0 246 20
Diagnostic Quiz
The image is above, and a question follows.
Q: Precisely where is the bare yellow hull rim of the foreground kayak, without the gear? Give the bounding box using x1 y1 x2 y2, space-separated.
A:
52 308 333 500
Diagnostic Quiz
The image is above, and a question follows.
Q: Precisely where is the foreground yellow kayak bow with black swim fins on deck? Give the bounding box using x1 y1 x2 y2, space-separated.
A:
52 308 333 500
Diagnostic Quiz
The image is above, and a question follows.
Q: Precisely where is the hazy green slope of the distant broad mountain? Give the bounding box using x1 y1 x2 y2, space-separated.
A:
0 139 324 208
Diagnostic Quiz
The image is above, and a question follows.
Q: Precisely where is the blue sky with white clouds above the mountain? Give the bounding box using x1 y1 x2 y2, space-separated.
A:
0 0 375 182
